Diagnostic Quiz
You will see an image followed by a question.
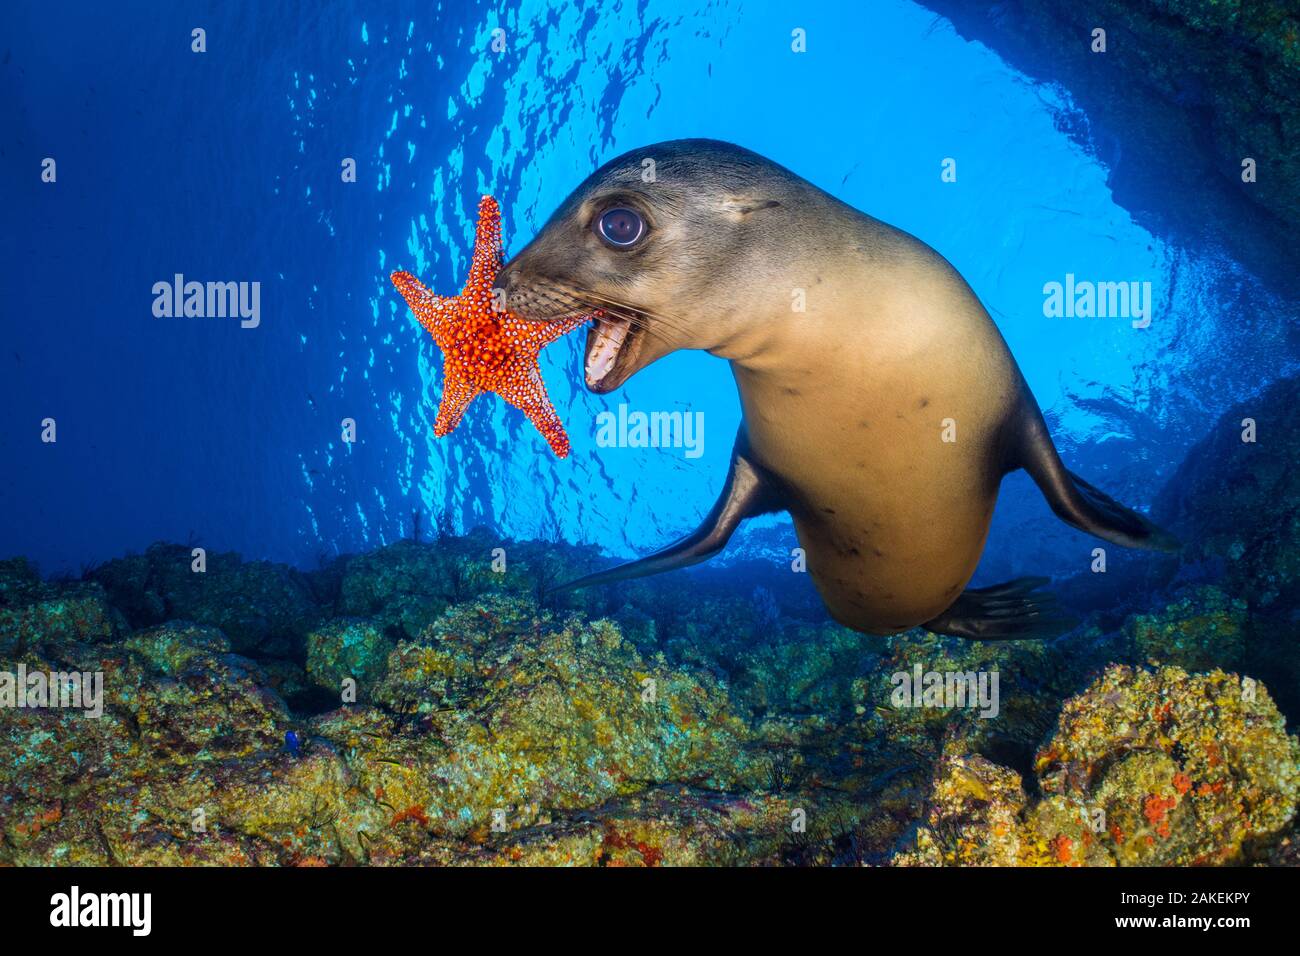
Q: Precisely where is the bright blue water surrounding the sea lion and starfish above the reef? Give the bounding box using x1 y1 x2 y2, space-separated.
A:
0 0 1296 579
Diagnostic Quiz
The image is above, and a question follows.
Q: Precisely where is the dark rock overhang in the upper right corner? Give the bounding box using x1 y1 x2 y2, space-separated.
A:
923 0 1300 290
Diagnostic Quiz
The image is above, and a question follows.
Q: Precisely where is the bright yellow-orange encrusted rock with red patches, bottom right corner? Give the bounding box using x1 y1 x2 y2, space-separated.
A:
892 666 1300 866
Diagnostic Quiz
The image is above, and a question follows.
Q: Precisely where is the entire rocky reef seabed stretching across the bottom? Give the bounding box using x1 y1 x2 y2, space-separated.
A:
0 476 1300 866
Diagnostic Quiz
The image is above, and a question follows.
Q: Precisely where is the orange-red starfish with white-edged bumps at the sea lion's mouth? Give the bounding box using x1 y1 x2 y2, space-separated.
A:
390 196 588 458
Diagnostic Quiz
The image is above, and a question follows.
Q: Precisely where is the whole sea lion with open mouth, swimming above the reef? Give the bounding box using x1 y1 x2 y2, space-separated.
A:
495 139 1177 640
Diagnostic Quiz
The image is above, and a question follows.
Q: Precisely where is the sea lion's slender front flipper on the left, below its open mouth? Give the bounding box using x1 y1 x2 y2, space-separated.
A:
555 442 779 591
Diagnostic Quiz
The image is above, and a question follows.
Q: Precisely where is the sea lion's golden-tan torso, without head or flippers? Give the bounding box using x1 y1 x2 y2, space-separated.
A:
733 234 1022 633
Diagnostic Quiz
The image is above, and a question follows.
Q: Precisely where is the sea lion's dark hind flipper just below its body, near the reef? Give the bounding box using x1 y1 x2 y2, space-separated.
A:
922 578 1078 641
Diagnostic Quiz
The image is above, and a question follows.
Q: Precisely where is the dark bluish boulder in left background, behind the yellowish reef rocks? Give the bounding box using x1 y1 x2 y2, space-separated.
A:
88 544 321 657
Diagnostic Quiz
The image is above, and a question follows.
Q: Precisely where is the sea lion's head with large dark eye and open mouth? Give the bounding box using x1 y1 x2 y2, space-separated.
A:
495 139 800 393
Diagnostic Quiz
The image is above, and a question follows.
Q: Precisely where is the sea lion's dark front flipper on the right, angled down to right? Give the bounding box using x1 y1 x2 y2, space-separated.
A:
1009 398 1180 551
